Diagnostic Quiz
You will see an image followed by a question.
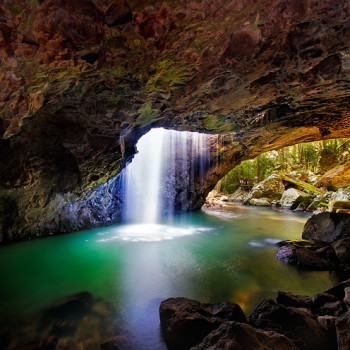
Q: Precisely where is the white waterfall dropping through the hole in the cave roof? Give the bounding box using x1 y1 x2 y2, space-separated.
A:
123 128 210 224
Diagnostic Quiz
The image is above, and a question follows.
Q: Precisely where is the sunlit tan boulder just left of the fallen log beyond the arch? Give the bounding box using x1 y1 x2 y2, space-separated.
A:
245 174 284 205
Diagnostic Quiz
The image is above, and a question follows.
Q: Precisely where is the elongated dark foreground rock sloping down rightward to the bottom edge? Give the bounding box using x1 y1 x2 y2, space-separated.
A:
248 299 332 350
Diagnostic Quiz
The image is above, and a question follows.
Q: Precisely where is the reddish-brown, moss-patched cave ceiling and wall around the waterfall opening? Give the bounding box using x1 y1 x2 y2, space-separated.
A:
0 0 350 240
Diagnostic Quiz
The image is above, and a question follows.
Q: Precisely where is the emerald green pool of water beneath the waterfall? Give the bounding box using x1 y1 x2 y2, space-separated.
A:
0 206 335 349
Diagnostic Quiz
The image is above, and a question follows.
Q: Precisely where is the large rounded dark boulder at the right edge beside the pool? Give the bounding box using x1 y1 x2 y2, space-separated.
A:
302 213 350 243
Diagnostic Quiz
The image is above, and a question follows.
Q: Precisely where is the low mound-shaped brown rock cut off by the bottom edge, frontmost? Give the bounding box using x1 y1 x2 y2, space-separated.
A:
191 322 298 350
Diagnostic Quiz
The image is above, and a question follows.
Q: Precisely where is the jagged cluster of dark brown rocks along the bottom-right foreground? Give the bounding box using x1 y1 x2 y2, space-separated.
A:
159 280 350 350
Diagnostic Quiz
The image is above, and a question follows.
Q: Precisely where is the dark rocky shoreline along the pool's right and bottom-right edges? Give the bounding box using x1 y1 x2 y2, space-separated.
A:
159 213 350 350
